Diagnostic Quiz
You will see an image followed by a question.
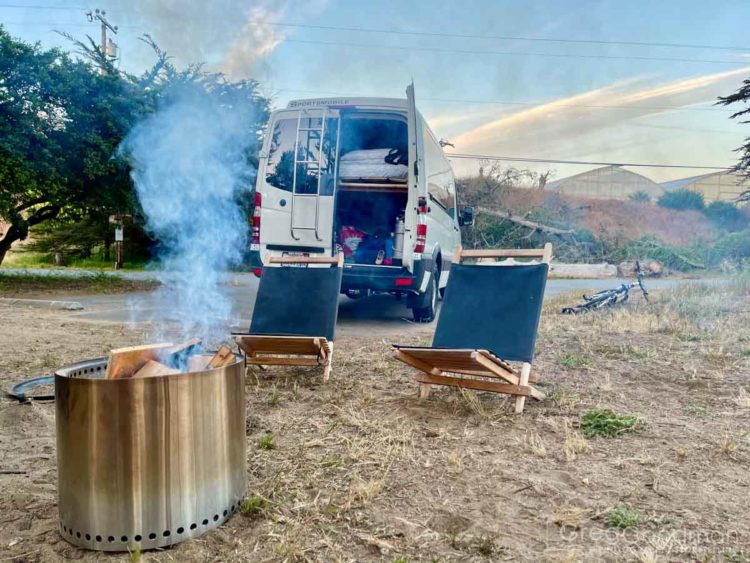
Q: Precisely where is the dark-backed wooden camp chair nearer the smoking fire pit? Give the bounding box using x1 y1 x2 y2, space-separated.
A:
234 254 344 381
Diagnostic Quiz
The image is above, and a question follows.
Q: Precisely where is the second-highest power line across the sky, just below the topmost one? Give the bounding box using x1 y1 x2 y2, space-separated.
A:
284 39 748 66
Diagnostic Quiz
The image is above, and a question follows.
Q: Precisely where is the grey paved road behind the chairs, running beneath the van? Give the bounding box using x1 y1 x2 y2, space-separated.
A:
2 269 688 336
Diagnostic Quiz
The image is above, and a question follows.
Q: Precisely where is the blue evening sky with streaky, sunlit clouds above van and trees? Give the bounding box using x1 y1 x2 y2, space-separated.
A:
0 0 750 180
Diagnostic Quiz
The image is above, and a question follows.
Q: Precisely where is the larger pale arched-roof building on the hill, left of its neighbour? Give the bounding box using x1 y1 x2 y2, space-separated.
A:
546 166 664 200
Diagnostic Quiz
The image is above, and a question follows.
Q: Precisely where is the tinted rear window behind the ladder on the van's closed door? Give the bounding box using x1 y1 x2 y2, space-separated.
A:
266 117 338 195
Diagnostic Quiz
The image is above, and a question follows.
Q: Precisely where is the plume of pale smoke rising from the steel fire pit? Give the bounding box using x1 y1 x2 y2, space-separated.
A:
124 86 256 340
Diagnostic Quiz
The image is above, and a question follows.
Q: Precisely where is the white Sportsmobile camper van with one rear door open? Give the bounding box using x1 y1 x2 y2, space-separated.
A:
250 86 473 322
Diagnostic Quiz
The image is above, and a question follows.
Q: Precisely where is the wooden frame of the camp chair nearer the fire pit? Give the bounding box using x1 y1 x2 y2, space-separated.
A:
234 253 344 381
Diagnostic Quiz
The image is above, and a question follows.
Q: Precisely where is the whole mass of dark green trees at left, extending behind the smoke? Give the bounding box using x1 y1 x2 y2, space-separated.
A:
0 26 269 264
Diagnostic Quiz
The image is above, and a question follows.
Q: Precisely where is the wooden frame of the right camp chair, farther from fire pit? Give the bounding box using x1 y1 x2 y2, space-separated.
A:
394 243 552 414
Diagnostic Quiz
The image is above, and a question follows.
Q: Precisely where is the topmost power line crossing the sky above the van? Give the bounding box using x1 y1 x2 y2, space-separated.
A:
0 4 750 51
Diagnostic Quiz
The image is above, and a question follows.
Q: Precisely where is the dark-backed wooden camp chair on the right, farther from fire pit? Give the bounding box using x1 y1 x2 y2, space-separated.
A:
394 244 552 413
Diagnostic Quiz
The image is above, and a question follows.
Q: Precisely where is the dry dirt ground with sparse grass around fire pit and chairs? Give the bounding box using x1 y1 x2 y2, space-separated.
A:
0 280 750 563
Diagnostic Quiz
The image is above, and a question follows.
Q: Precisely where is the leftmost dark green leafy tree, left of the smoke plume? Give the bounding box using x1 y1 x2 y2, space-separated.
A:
0 28 139 263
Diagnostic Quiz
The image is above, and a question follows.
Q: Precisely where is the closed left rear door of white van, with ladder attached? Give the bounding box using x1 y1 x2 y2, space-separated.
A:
259 108 340 254
